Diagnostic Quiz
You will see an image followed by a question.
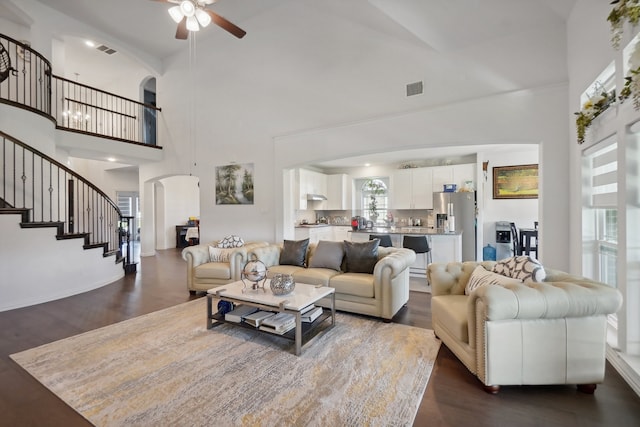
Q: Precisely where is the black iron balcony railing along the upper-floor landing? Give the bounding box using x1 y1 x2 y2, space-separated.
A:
0 34 161 146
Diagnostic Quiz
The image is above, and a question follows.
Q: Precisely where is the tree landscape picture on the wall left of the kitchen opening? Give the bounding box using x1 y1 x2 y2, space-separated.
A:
216 163 253 205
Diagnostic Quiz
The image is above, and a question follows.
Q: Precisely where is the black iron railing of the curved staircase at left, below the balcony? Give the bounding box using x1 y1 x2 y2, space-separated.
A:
0 131 135 271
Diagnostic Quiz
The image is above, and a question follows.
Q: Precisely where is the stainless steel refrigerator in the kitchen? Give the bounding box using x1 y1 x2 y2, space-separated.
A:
433 192 477 261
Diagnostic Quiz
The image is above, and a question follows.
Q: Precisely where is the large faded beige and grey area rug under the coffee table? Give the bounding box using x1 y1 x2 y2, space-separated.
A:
11 298 440 426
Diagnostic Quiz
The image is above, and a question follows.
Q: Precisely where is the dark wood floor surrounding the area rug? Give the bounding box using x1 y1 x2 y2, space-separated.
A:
0 249 640 427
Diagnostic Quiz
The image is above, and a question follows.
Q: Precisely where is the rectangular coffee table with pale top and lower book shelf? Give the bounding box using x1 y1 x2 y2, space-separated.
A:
207 280 336 356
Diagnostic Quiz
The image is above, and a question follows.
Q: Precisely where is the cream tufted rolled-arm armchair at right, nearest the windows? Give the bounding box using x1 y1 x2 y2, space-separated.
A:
427 262 622 393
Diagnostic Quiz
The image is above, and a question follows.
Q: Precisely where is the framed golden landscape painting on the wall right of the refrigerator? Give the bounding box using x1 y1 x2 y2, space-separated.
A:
493 165 538 199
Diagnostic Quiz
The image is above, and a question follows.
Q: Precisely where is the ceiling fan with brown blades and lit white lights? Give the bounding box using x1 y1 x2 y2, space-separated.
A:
152 0 247 40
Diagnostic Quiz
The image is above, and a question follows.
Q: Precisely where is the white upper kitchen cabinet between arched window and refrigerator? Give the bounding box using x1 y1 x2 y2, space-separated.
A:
391 168 433 209
